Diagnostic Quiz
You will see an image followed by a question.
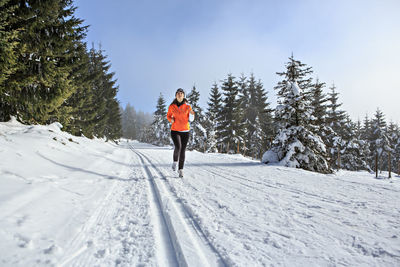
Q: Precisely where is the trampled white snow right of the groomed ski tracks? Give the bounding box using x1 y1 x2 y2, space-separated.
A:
141 145 400 266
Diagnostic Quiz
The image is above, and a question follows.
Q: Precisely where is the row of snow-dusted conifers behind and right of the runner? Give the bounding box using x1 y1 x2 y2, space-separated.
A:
146 56 400 173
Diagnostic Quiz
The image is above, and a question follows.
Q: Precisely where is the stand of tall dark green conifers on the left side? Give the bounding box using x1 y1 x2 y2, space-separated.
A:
0 0 122 139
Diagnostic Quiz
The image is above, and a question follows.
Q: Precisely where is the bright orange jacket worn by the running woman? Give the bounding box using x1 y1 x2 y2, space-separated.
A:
167 103 192 131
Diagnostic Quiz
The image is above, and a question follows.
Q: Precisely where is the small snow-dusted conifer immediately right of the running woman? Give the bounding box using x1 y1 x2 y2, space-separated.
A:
187 86 207 151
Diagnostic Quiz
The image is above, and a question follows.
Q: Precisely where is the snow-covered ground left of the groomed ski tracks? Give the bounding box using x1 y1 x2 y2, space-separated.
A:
0 122 156 266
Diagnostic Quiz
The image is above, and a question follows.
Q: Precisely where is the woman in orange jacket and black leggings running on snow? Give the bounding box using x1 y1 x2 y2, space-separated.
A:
167 88 194 177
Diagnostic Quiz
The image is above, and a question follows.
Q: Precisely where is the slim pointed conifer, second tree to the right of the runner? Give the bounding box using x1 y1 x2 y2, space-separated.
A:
205 83 222 152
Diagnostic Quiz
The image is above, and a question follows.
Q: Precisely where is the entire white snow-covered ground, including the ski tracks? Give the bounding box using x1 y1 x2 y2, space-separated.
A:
0 121 400 266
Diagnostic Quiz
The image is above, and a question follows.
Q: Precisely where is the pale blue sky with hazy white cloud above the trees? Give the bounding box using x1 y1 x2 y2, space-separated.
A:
75 0 400 123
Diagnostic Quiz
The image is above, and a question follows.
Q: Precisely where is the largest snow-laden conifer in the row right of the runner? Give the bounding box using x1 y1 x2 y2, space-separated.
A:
262 56 332 173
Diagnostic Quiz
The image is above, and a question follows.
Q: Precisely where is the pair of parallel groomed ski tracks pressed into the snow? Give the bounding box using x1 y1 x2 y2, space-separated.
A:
132 148 226 266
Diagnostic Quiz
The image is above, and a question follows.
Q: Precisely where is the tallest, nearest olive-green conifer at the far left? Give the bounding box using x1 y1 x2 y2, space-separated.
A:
2 0 86 123
